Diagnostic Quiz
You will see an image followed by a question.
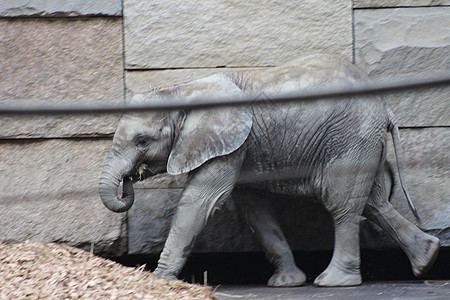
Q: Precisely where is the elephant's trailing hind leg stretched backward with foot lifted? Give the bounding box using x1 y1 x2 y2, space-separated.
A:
364 171 439 276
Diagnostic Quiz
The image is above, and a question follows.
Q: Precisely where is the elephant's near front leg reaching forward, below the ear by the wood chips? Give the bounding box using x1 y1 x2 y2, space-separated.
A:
155 151 243 279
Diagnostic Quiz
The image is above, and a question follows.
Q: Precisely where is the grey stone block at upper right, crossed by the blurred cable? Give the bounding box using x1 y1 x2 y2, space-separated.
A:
355 7 450 127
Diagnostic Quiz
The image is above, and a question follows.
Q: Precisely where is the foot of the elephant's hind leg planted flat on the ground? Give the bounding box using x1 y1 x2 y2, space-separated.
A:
314 265 362 286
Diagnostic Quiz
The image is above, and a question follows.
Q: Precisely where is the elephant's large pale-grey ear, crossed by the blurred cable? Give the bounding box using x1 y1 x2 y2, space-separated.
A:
167 75 253 175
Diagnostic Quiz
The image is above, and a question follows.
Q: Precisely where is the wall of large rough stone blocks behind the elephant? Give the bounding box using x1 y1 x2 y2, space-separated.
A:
0 0 450 255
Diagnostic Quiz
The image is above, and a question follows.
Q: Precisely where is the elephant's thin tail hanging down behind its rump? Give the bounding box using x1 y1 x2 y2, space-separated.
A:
386 107 422 227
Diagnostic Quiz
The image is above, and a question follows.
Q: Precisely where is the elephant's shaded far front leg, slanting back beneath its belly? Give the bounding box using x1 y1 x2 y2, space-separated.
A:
233 189 306 287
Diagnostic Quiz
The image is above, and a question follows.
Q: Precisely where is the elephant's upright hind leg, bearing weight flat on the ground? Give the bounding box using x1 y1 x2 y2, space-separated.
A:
314 161 375 286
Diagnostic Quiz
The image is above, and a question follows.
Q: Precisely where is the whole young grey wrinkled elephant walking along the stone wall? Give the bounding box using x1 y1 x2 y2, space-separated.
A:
99 55 439 286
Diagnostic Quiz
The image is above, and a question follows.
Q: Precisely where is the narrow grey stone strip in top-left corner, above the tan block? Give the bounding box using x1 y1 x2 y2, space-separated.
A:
0 0 122 17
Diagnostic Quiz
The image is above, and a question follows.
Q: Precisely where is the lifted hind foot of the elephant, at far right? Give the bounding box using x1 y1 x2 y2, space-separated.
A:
409 233 440 276
